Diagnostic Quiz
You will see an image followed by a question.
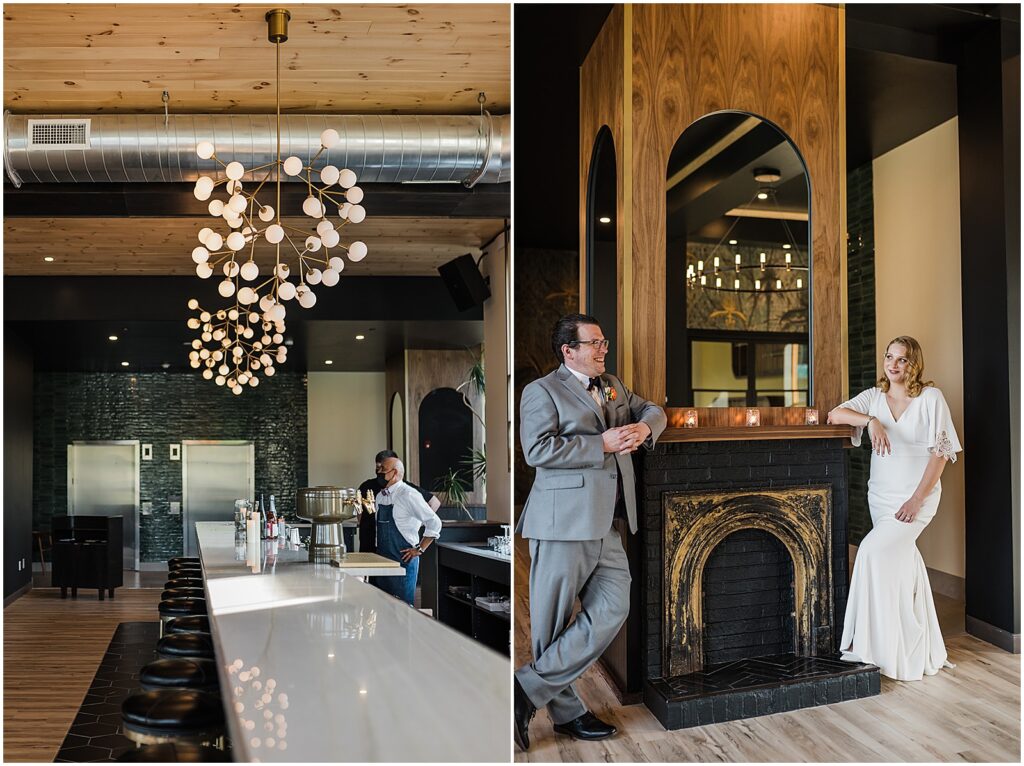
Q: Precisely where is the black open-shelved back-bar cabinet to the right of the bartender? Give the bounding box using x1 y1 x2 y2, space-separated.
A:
436 543 512 656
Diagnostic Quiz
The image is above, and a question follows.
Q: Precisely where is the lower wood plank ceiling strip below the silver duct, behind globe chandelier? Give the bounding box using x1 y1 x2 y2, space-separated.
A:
3 216 504 280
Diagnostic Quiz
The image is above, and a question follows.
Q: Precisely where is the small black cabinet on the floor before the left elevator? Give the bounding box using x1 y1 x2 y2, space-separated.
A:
50 516 124 601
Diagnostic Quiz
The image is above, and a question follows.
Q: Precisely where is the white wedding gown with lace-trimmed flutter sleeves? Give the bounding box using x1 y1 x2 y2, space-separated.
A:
840 386 962 681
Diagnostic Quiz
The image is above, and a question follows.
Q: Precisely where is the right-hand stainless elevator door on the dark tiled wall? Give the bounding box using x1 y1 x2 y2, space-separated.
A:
181 441 255 556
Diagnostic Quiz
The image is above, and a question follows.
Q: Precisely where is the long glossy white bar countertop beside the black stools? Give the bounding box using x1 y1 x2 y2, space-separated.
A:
196 521 512 763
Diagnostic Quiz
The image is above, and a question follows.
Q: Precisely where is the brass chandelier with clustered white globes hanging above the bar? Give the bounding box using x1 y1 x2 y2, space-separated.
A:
187 8 367 394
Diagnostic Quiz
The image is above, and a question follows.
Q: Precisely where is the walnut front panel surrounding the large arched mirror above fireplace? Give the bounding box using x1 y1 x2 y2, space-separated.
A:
581 4 845 411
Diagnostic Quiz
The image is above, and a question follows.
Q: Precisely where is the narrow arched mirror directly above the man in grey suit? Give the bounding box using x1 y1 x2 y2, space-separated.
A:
587 126 618 375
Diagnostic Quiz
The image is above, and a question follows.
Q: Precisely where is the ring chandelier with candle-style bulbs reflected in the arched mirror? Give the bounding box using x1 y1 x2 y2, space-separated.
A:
686 168 808 293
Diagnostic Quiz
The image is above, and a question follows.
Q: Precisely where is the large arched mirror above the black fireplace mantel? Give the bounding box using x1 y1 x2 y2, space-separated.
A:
666 112 811 407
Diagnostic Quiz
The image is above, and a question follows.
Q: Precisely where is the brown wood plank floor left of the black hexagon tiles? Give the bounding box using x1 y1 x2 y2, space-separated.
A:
3 588 160 762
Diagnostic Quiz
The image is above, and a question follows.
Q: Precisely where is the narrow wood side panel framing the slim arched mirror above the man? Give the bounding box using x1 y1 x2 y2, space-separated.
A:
580 5 629 374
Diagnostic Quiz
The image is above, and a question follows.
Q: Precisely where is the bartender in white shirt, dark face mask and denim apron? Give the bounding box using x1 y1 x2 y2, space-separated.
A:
370 458 441 606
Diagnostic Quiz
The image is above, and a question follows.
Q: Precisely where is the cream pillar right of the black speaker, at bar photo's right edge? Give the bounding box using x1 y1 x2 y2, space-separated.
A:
480 230 512 523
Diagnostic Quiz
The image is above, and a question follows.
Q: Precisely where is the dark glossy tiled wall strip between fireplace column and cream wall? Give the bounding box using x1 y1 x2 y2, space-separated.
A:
846 163 878 545
